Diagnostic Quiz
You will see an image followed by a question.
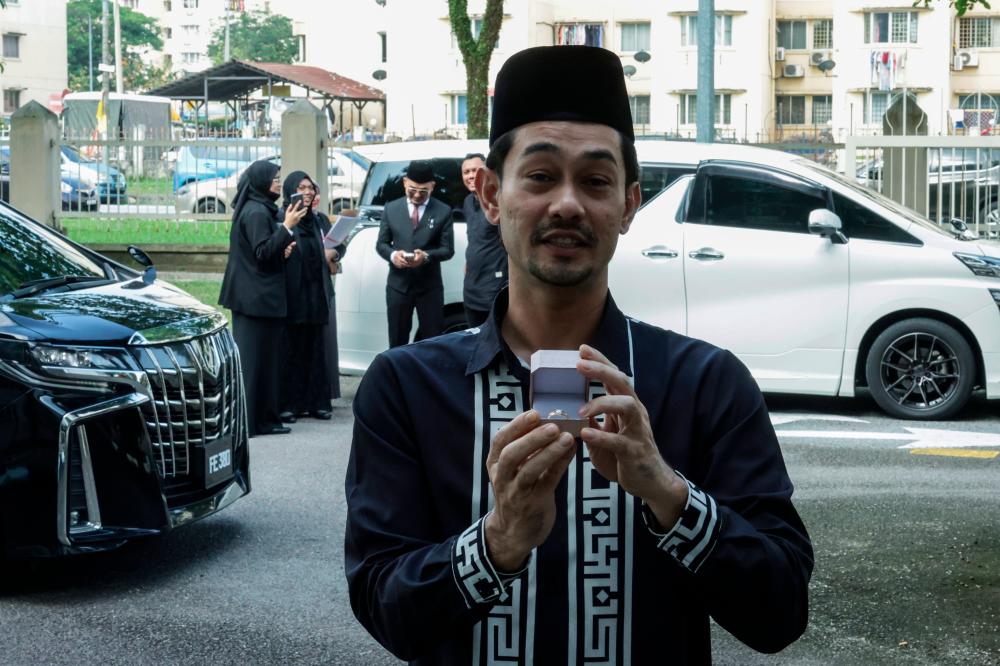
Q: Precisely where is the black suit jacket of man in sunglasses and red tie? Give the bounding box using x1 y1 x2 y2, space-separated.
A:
375 197 455 293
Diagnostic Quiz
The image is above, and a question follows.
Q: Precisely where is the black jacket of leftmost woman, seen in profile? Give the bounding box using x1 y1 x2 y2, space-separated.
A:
219 201 294 318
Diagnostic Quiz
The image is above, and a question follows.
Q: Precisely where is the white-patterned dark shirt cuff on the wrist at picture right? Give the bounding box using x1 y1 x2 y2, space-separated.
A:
642 472 721 573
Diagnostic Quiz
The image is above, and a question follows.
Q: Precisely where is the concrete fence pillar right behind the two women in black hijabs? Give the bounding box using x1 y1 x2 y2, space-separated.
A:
281 99 330 211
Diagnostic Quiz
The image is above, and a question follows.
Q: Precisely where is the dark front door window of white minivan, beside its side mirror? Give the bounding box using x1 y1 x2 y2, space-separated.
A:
706 175 826 234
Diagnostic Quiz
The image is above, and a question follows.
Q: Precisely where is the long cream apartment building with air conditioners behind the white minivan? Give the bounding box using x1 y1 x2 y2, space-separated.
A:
284 0 1000 141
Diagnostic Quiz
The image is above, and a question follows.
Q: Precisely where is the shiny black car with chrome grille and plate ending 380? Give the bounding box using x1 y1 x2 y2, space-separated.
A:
0 198 250 559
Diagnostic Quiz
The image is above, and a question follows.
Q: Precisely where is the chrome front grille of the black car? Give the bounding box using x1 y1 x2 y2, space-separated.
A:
132 328 245 478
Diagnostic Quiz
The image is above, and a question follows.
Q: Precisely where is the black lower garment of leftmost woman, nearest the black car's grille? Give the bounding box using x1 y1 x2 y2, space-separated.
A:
233 312 288 437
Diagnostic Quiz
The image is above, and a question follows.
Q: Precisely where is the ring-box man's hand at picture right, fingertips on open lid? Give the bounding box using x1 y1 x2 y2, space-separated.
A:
576 345 688 529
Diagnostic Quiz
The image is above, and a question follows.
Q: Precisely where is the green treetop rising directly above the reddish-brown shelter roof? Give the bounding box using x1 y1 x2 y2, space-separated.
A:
208 11 299 65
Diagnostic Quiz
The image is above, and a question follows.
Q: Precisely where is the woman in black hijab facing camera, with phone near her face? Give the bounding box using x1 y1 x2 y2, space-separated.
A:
278 171 331 422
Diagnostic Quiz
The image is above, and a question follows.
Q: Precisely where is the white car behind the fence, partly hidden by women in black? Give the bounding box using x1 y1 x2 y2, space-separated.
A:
175 150 368 213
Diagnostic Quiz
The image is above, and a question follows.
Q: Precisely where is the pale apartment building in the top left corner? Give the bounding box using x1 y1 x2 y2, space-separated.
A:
0 0 66 118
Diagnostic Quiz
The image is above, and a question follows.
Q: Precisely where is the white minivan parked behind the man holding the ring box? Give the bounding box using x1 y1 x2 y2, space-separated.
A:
337 142 1000 419
